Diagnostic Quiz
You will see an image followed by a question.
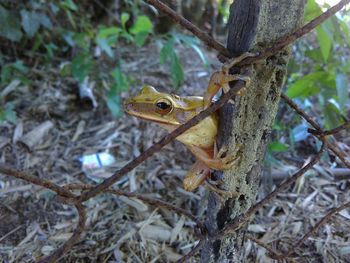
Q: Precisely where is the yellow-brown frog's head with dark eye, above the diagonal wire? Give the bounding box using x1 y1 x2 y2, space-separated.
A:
124 86 203 125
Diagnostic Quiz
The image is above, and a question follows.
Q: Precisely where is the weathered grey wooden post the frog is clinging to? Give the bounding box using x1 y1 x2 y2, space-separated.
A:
201 0 305 262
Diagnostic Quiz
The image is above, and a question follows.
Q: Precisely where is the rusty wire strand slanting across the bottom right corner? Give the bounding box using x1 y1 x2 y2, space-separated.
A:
269 202 350 260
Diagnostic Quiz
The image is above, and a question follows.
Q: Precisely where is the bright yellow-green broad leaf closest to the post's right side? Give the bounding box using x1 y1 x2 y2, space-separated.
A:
287 72 328 98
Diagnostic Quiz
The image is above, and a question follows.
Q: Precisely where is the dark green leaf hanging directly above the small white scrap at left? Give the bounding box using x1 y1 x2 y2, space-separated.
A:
71 52 92 83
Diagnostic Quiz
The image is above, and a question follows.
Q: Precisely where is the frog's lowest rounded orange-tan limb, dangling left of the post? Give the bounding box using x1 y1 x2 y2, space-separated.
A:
183 161 210 192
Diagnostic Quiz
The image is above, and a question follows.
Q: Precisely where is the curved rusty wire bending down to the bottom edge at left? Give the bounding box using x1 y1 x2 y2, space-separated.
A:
38 202 86 263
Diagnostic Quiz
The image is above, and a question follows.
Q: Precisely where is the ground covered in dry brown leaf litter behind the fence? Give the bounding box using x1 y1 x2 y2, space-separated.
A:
0 44 350 262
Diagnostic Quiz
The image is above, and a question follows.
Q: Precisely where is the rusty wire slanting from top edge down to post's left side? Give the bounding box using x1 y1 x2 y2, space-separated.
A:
145 0 232 57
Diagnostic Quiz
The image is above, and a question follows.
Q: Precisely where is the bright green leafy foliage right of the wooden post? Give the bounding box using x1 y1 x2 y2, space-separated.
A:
286 0 350 148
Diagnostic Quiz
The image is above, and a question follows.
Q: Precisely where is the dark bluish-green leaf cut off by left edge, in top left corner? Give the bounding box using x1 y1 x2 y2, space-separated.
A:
0 5 23 42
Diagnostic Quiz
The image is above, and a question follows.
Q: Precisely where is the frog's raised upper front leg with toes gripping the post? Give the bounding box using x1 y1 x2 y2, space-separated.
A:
204 53 254 108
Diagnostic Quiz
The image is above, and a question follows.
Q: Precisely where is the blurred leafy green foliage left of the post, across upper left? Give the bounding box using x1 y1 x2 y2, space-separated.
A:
0 0 206 119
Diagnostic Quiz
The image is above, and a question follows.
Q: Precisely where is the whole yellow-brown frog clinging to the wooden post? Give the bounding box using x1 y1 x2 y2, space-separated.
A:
124 54 251 191
